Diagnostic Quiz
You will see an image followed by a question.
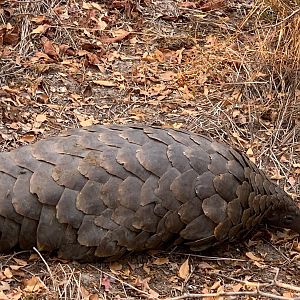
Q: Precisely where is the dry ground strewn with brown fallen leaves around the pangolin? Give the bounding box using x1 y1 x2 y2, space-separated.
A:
0 0 300 300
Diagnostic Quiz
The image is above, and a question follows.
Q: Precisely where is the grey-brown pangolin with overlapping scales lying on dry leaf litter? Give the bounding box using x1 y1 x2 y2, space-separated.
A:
0 125 300 260
